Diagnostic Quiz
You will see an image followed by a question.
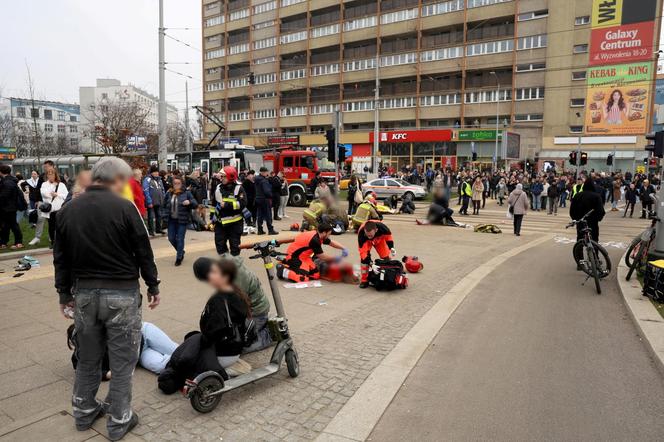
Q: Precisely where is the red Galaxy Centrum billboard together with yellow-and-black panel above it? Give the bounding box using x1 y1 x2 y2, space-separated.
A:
589 0 657 66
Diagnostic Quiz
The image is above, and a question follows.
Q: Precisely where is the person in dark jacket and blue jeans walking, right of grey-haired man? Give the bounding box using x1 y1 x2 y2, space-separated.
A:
164 177 198 267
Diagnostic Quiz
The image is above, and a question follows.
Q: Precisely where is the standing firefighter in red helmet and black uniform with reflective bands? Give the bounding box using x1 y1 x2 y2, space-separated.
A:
214 166 247 256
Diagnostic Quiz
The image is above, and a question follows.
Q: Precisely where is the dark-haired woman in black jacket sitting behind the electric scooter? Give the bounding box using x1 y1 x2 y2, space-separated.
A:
194 259 256 377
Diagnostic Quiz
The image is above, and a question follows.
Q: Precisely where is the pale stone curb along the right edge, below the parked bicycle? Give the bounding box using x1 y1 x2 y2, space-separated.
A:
617 255 664 373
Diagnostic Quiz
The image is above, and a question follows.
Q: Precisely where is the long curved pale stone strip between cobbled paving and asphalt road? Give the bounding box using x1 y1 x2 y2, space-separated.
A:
316 235 552 442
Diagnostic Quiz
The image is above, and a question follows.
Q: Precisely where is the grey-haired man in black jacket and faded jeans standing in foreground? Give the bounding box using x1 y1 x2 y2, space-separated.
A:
53 157 160 440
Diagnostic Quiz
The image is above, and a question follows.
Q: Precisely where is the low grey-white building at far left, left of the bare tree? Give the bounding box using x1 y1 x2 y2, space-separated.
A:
7 98 81 155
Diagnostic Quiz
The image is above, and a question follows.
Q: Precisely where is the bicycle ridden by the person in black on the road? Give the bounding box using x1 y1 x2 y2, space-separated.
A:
565 210 611 295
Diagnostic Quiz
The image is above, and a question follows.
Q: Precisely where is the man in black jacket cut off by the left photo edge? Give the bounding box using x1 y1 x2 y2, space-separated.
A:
0 164 27 249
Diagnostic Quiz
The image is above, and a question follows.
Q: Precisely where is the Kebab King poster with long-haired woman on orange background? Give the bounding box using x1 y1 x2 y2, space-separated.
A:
586 63 655 135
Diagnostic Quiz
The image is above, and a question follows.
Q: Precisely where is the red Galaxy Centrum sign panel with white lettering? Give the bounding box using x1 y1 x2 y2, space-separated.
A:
589 21 655 66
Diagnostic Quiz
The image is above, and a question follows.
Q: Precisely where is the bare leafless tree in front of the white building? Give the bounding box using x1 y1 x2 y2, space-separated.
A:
89 100 155 154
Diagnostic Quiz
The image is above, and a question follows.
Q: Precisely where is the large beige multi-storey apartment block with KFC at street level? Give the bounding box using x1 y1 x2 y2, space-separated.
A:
202 0 661 169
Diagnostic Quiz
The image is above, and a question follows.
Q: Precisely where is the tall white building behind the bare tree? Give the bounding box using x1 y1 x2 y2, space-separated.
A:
79 78 178 152
